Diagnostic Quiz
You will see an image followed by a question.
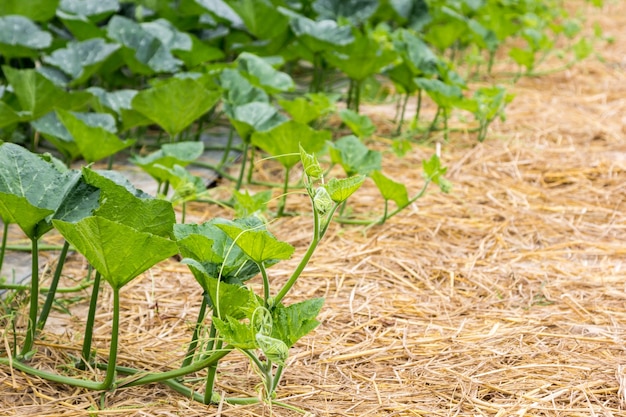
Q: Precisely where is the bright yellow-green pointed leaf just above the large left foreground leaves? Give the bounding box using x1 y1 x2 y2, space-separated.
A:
57 109 135 162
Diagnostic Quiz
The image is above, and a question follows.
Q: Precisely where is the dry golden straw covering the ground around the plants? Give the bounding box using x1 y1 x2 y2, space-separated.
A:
0 1 626 417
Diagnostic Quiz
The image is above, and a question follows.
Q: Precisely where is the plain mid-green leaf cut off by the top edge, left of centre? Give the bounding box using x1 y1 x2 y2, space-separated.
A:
227 0 289 39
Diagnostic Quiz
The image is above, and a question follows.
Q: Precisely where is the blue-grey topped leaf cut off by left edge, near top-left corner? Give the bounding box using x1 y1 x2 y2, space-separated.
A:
0 15 52 57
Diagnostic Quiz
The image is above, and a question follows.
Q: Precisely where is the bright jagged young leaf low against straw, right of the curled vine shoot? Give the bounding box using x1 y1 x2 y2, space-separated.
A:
272 298 324 347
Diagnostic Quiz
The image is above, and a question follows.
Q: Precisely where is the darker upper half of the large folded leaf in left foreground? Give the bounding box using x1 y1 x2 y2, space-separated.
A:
83 168 176 237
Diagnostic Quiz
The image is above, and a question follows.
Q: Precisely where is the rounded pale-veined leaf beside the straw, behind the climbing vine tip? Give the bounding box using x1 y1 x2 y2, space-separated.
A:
329 135 382 176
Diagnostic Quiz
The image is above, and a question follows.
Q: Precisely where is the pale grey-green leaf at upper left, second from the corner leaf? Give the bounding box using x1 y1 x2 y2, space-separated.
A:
43 38 120 84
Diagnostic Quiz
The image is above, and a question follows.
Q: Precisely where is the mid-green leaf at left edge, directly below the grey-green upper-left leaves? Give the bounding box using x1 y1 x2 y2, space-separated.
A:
2 66 91 120
